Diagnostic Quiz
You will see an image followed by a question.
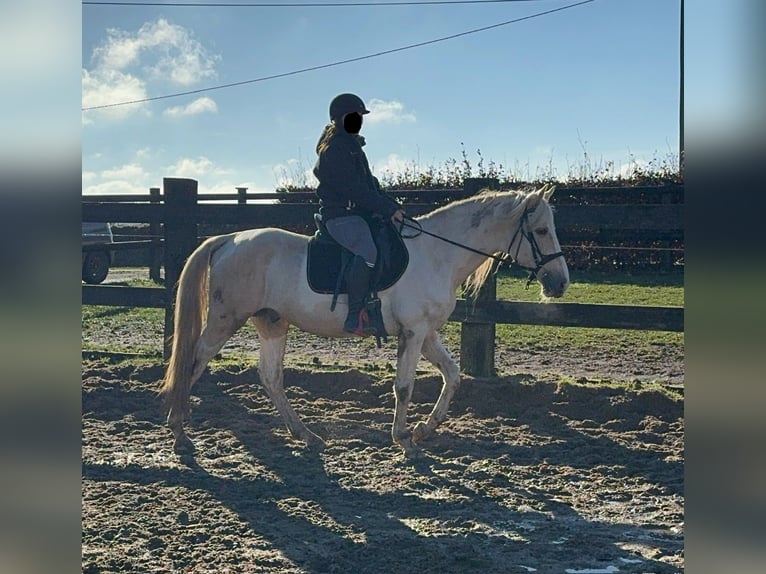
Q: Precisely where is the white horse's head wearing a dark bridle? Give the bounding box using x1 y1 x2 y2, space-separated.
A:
508 184 569 297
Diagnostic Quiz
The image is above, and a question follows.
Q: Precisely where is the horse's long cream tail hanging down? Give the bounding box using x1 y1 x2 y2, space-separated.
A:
160 235 231 416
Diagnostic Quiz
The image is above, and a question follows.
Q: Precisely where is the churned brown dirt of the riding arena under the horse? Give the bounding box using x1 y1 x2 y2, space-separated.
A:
82 326 684 574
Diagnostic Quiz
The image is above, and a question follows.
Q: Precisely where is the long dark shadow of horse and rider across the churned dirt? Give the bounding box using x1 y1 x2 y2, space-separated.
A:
83 366 674 573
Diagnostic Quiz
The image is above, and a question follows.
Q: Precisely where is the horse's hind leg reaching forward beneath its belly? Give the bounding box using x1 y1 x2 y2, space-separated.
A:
252 312 324 445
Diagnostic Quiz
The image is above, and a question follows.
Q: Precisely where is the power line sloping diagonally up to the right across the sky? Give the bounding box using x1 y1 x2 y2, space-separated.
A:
81 0 595 112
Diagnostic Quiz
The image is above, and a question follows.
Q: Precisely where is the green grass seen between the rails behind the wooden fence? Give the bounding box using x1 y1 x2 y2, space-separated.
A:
82 271 684 356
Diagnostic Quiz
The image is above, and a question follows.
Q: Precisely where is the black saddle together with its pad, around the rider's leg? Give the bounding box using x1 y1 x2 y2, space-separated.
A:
306 214 410 294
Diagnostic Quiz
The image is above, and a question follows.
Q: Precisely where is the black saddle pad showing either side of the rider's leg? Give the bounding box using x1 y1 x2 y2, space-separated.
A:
306 229 410 294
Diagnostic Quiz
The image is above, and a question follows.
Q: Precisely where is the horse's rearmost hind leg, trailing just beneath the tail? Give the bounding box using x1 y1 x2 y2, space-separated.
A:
167 316 246 454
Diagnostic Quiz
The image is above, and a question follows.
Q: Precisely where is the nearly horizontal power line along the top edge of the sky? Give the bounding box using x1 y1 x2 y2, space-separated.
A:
82 0 560 8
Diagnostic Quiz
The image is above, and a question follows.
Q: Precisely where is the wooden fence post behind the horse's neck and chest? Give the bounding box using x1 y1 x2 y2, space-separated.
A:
460 177 500 377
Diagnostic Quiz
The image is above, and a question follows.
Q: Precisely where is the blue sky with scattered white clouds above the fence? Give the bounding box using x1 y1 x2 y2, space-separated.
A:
81 0 688 194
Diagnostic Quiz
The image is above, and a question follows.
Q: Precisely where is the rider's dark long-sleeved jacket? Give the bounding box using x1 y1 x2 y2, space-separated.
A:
314 124 400 221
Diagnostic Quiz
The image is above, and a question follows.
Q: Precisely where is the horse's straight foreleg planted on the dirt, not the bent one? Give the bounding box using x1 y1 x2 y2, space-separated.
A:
391 330 423 456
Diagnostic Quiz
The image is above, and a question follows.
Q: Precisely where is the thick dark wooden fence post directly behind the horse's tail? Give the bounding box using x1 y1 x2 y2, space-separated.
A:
162 177 197 359
